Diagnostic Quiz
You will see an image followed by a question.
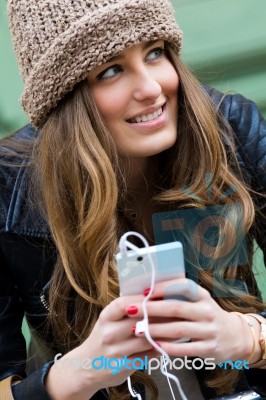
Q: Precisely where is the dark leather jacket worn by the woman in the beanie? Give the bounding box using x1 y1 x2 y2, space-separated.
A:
0 88 266 400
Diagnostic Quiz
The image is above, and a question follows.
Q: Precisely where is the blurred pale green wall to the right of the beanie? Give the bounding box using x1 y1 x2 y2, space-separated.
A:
173 0 266 115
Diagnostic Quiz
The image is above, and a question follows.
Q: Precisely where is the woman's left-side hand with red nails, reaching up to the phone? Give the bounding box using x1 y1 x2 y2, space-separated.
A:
46 295 158 400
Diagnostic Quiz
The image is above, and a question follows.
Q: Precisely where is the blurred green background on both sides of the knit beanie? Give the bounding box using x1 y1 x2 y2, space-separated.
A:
0 0 266 136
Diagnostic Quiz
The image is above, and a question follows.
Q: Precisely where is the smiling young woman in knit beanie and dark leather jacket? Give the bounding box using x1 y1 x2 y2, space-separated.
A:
0 0 266 400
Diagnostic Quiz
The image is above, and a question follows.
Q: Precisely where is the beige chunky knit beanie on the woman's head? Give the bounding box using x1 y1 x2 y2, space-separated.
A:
8 0 182 128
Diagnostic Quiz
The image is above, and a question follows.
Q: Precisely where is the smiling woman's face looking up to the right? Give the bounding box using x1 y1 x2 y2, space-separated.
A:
88 40 179 158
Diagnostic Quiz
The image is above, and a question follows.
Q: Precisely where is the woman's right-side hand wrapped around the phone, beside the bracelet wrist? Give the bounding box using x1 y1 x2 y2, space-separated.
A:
125 279 252 363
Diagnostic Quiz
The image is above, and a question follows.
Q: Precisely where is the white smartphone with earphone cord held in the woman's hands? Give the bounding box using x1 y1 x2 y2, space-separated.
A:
115 242 185 296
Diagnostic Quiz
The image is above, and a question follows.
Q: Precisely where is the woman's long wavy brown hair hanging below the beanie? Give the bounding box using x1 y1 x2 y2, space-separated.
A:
25 44 263 399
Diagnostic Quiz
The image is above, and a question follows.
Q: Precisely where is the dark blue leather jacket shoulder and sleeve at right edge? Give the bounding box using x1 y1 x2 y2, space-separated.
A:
207 86 266 263
